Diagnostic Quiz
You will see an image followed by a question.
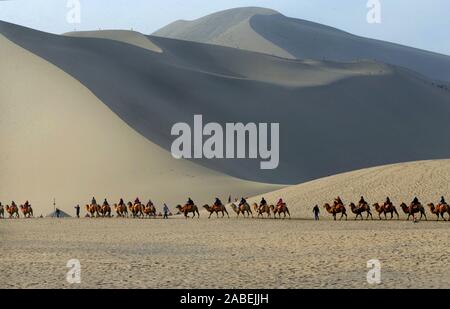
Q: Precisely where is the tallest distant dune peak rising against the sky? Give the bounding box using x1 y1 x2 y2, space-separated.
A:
154 7 450 82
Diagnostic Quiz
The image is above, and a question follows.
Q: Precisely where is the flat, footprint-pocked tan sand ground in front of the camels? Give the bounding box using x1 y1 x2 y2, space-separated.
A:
0 215 450 289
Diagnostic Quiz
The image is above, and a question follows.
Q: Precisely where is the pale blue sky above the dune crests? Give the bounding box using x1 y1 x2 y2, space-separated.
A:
0 0 450 55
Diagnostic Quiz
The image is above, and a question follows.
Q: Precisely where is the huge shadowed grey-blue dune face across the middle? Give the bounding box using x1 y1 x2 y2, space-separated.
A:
0 23 450 184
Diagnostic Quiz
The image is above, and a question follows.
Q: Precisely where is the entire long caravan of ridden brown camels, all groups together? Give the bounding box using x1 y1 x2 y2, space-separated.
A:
0 197 450 221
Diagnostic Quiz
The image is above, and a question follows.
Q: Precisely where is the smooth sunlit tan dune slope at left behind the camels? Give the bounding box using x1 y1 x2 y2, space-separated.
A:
0 35 280 215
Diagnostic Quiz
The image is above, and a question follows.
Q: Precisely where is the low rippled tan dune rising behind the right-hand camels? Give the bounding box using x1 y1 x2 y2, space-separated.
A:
249 160 450 219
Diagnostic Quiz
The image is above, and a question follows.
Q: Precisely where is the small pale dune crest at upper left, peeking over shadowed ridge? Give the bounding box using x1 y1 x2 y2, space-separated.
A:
64 30 162 53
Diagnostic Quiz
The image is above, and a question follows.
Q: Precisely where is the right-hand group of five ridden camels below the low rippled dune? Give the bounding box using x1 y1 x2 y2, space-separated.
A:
323 197 450 221
